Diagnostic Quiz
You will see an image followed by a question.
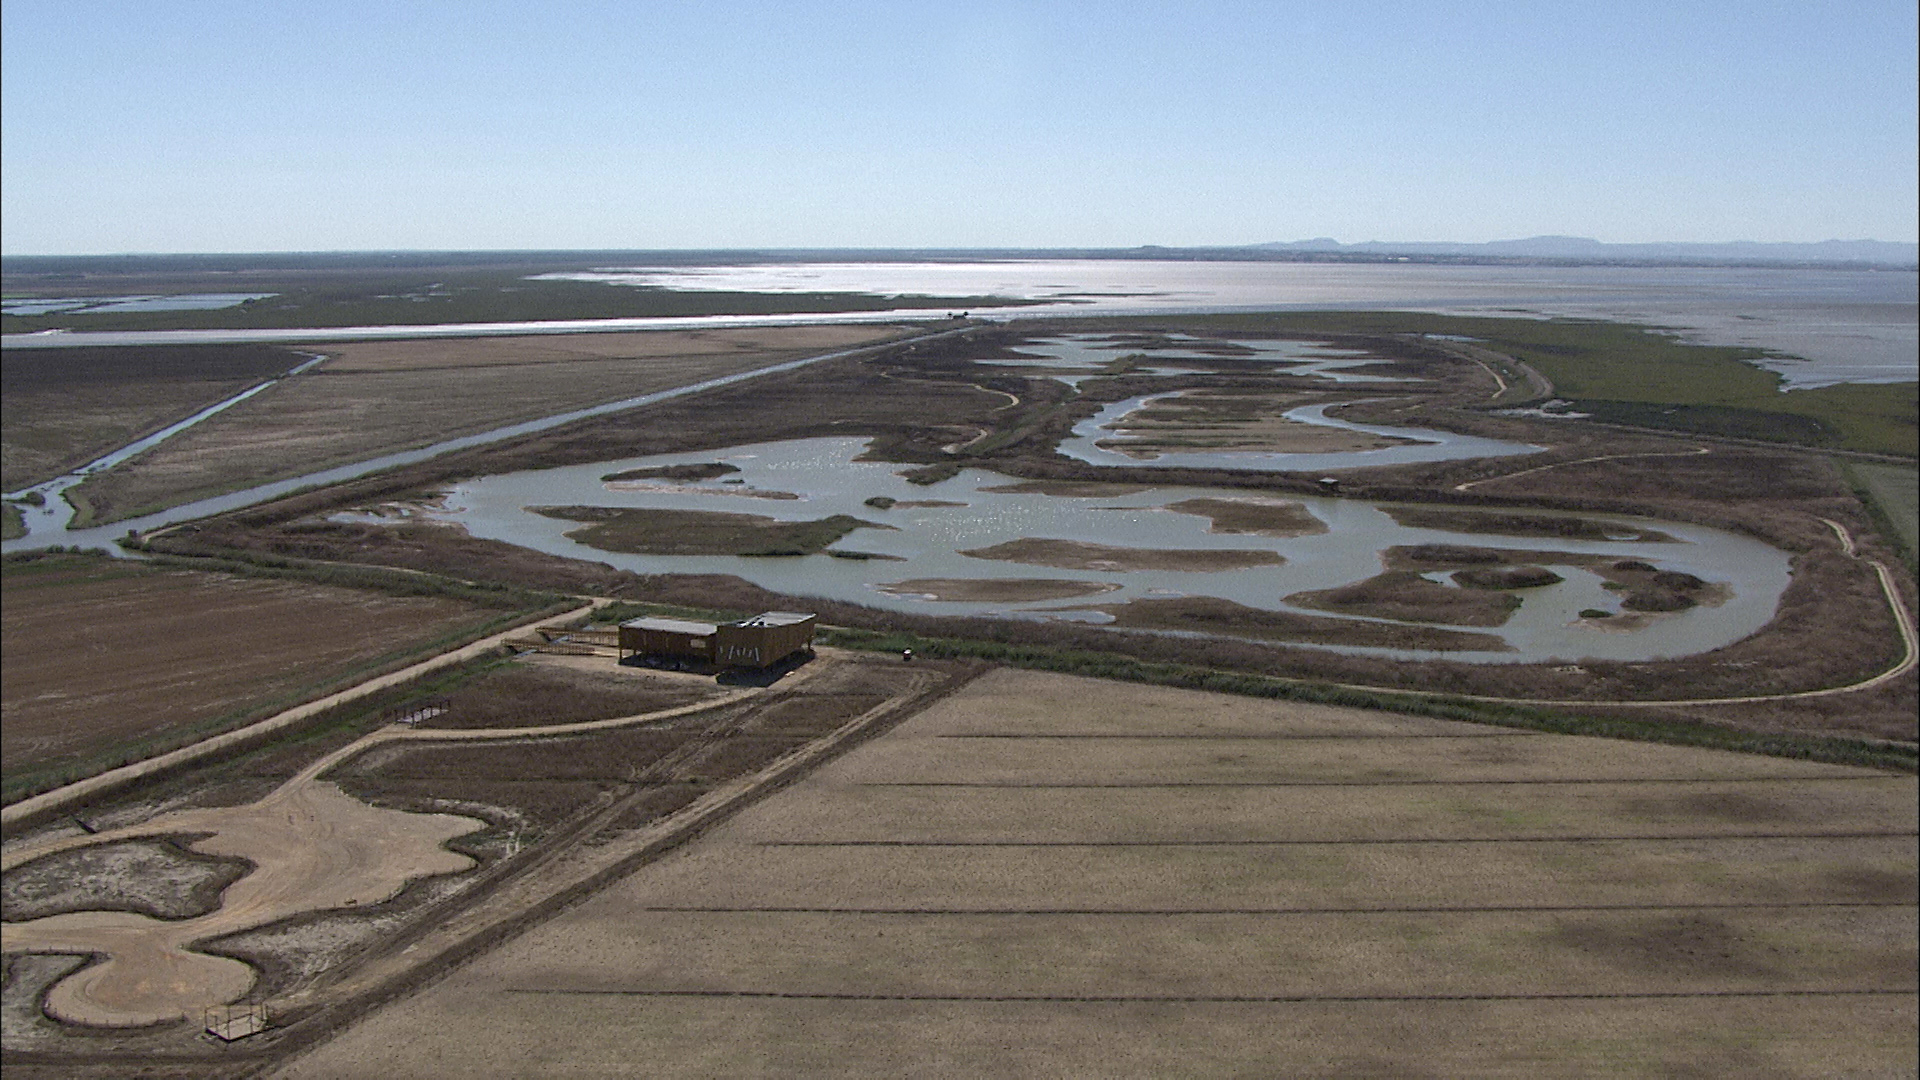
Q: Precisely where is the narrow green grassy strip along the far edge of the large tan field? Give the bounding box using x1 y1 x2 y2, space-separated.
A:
820 628 1920 773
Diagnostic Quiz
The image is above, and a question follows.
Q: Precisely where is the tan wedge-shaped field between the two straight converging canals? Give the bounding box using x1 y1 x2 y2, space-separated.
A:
71 327 899 523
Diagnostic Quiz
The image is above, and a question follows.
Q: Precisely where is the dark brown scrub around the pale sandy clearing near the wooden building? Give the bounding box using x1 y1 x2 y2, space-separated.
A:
6 645 970 1074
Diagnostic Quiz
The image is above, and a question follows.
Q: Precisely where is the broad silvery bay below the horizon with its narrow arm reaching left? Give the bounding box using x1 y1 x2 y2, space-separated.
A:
4 259 1920 386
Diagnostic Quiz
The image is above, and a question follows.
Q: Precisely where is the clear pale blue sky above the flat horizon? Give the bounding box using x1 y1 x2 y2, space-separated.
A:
0 0 1920 254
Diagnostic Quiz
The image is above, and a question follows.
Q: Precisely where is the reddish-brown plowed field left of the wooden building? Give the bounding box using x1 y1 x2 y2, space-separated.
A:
0 555 501 778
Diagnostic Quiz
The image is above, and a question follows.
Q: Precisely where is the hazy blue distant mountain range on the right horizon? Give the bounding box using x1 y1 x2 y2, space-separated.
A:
1252 236 1920 267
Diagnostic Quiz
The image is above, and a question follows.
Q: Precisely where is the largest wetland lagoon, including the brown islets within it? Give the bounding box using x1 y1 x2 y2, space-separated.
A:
426 438 1788 663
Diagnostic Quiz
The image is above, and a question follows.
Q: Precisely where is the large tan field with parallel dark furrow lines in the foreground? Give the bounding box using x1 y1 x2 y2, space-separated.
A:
284 671 1920 1080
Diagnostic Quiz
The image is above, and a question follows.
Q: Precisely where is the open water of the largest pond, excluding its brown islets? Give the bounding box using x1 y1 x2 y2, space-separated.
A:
440 438 1788 661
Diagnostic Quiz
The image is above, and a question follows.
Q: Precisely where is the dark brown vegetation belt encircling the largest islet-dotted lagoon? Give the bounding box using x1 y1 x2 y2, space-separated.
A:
131 325 1916 742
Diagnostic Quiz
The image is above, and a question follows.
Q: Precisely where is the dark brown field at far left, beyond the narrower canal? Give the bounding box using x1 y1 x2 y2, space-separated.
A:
0 346 305 492
